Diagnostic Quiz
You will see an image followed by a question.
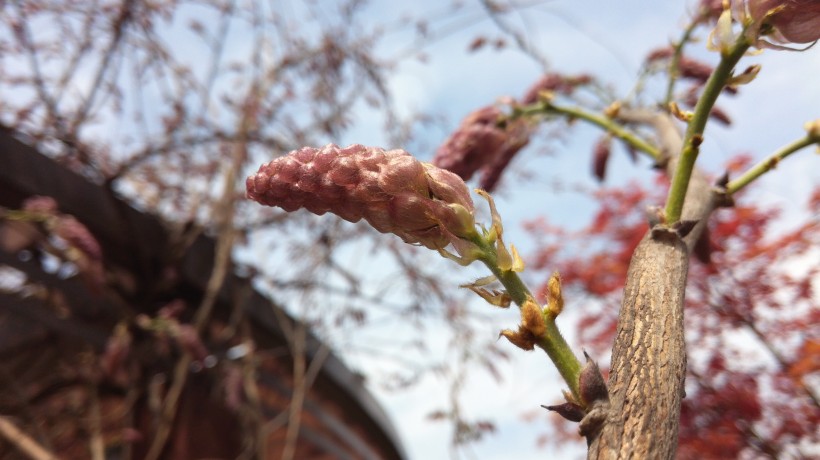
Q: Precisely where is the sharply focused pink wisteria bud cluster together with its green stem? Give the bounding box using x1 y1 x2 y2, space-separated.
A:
246 144 592 406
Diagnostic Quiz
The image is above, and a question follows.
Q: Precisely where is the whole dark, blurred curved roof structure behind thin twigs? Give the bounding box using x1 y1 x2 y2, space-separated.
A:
0 129 405 459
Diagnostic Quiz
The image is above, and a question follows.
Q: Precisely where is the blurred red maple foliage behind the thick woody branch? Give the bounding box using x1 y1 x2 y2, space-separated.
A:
528 165 820 459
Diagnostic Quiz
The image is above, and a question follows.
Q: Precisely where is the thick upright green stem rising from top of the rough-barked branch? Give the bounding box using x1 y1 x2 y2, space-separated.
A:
666 35 750 225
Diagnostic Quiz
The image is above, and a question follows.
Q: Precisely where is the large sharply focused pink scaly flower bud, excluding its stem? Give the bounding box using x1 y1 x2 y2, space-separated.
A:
246 144 475 249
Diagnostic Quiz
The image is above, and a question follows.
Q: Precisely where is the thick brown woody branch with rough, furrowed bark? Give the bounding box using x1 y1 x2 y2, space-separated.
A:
582 111 722 459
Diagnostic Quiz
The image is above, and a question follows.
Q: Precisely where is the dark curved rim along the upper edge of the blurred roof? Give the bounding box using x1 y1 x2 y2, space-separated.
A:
0 127 407 459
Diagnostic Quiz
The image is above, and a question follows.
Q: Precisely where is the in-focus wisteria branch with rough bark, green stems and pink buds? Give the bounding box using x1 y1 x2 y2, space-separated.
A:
246 1 820 458
